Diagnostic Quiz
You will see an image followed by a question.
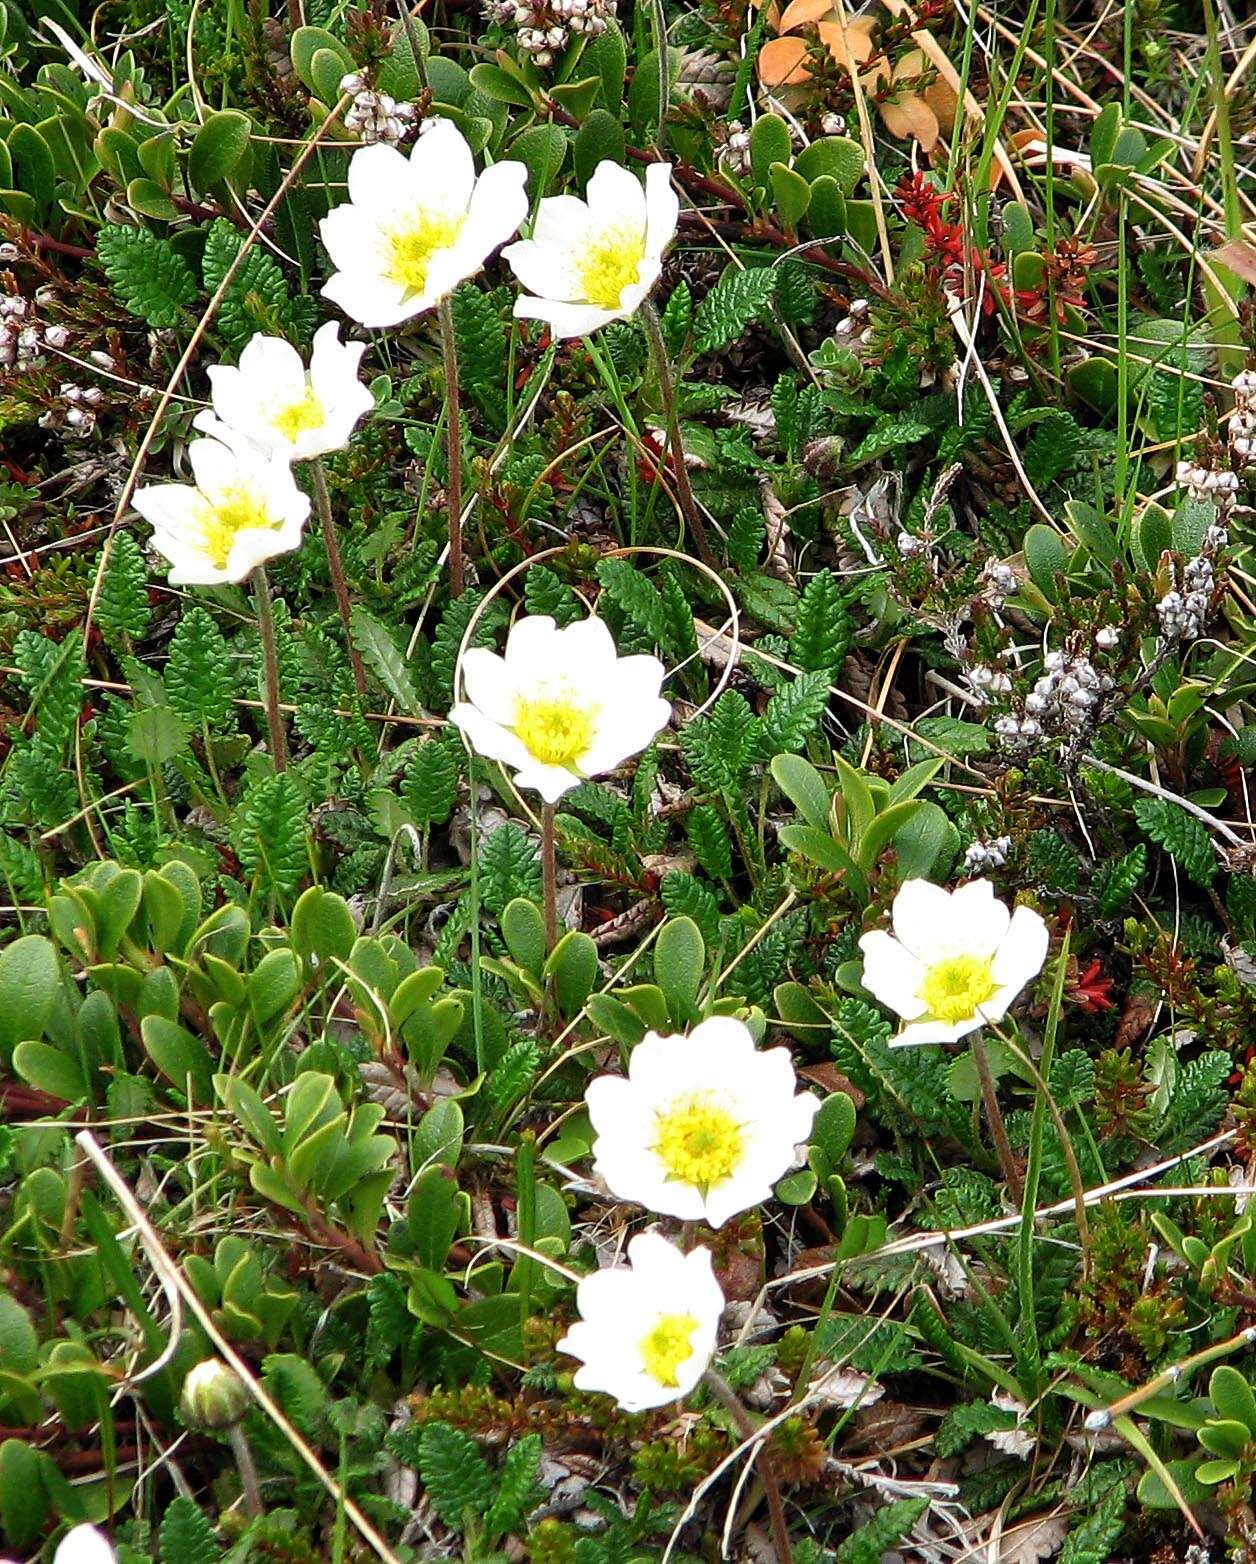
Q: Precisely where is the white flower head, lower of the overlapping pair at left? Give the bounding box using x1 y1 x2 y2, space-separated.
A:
133 439 310 587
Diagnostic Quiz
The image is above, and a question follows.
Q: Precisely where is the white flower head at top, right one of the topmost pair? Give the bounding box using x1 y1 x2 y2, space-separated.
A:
502 161 680 336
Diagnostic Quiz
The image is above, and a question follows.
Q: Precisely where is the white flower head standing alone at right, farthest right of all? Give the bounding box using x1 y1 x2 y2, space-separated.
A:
859 879 1048 1045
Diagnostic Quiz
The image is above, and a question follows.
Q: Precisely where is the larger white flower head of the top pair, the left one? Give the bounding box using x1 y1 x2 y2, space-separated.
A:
319 119 527 325
